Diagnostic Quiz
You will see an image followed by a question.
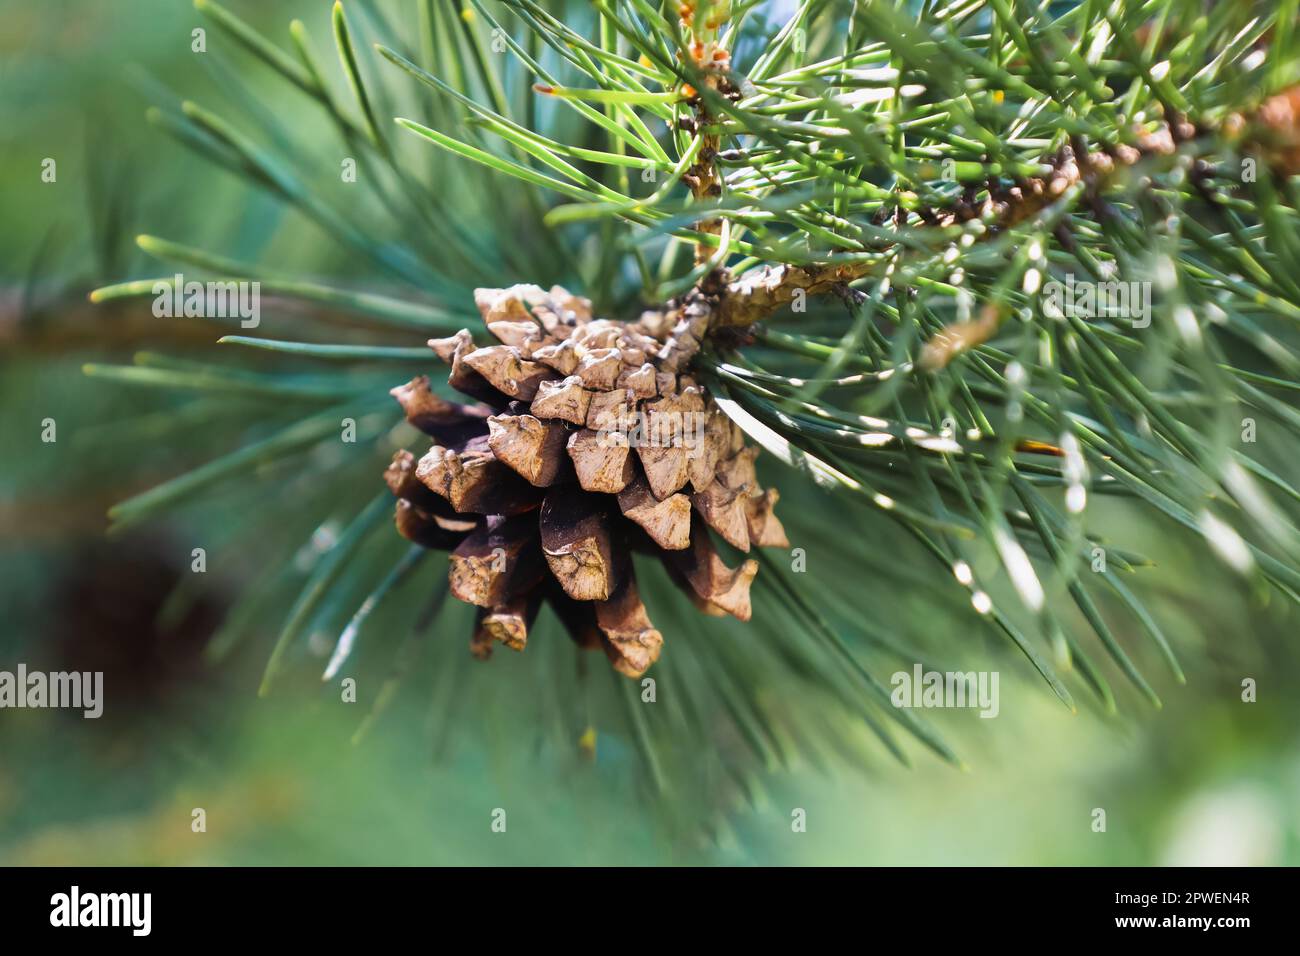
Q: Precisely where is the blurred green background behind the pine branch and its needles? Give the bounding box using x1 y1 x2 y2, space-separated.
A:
0 0 1300 865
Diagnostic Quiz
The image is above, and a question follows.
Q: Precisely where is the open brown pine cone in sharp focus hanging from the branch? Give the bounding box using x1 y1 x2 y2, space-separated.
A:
385 285 789 678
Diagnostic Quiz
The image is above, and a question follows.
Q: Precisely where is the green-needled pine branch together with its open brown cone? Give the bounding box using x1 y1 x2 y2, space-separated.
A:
95 0 1300 783
